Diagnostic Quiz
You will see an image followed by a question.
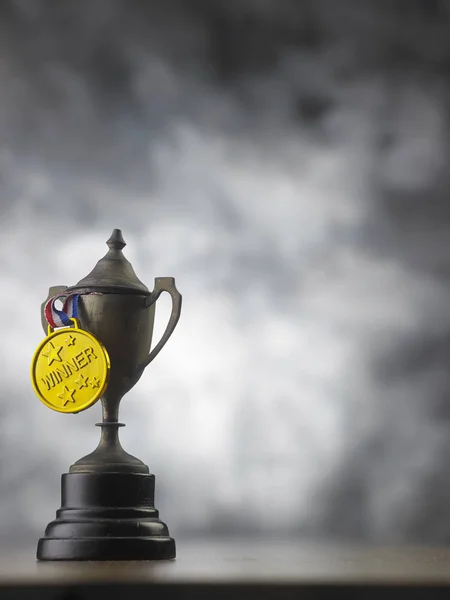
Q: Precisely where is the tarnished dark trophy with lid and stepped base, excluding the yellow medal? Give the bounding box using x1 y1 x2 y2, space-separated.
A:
38 229 181 560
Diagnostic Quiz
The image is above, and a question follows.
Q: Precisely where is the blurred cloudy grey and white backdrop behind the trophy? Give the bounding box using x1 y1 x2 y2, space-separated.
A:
0 0 450 544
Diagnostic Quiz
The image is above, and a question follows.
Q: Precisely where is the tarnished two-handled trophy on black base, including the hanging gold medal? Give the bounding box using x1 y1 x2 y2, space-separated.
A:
31 229 181 560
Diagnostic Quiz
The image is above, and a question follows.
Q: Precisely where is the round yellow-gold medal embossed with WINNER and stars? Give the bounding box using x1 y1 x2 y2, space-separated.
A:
31 319 110 413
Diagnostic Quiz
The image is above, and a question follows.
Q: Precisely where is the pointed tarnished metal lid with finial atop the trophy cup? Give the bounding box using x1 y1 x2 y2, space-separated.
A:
68 229 150 295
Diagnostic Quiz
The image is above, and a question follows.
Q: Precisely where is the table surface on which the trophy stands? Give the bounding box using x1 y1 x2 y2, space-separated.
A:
4 540 450 600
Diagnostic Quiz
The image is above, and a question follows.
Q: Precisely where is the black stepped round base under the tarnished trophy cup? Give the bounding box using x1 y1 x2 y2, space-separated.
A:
37 473 176 561
